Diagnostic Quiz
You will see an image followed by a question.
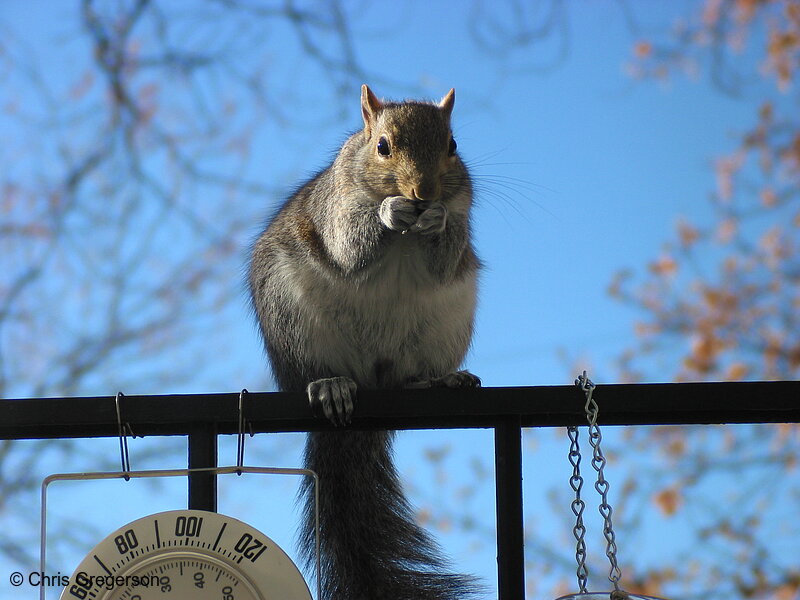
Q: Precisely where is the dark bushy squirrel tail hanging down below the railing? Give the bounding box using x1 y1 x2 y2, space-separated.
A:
300 431 479 600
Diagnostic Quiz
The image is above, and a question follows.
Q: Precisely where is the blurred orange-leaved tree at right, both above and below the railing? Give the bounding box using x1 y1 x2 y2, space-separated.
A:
609 0 800 600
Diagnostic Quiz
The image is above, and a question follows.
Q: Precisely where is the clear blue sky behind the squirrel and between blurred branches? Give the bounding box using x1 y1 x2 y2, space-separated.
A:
0 0 792 590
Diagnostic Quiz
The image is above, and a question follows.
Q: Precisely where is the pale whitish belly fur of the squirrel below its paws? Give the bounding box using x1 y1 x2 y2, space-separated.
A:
290 239 476 387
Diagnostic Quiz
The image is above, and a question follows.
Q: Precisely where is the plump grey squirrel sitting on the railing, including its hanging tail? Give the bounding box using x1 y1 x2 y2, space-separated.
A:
249 85 480 600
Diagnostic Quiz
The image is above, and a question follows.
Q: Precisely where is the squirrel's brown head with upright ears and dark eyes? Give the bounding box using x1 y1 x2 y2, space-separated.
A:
361 85 467 202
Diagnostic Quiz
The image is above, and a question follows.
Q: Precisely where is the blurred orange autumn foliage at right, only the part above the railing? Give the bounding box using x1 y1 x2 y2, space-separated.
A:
610 0 800 380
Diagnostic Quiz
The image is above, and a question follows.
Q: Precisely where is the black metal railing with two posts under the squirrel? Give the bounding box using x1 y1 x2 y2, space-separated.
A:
0 381 800 600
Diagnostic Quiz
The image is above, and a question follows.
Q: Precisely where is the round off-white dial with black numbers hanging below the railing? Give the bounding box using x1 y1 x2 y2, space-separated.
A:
61 510 311 600
